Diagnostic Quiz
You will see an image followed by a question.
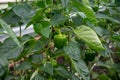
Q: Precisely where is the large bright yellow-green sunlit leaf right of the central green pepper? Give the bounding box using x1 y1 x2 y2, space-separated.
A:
75 25 104 50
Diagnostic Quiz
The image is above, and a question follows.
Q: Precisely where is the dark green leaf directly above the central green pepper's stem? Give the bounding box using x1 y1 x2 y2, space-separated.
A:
51 14 68 26
